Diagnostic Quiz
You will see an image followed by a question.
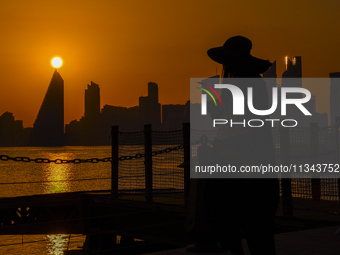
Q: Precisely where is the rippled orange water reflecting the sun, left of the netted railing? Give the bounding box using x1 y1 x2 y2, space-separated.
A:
0 146 111 255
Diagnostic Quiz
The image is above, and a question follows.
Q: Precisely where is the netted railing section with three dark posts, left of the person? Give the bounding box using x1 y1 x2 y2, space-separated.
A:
111 123 190 202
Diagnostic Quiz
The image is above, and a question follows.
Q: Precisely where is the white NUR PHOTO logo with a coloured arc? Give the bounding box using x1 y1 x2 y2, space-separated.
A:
196 80 312 127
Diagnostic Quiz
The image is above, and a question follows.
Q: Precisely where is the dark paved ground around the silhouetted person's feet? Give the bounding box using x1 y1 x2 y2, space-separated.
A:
143 226 340 255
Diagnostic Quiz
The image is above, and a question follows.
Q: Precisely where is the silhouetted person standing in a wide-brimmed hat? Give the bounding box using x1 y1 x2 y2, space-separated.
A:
194 36 279 255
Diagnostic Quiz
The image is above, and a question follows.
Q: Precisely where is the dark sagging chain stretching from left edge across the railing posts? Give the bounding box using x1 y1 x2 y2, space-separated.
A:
0 145 184 164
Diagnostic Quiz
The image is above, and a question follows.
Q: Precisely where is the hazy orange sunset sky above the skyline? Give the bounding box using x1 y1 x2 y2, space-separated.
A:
0 0 340 127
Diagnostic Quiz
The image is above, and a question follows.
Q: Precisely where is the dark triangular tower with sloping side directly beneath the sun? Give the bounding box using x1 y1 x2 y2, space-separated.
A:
32 69 64 146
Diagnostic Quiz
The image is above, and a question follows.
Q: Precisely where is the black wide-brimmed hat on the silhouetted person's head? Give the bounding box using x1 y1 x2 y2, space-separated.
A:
208 35 272 74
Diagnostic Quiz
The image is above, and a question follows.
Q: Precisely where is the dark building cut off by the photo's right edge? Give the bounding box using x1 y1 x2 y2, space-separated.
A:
329 72 340 125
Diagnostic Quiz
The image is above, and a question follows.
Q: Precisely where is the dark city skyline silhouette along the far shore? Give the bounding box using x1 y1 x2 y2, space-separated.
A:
0 56 340 146
